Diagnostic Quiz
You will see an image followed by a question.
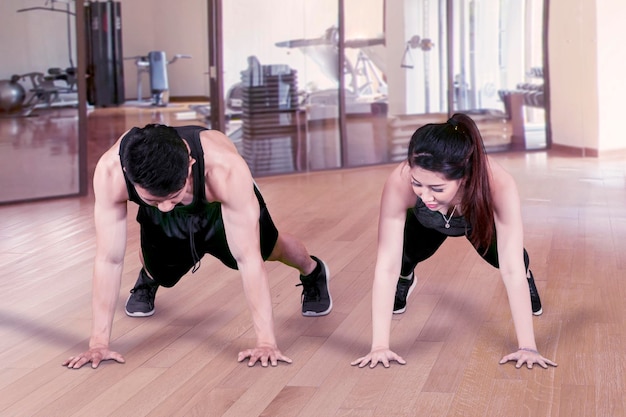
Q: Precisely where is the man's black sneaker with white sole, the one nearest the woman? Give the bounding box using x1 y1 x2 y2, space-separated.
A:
297 256 333 317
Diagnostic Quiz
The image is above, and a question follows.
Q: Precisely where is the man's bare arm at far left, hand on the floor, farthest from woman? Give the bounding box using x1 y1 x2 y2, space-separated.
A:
64 151 127 368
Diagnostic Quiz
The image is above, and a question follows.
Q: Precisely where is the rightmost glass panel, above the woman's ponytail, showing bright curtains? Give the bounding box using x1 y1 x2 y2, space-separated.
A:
452 0 546 150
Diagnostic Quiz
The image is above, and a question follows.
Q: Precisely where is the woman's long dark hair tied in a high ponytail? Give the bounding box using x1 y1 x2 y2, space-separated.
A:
408 113 494 248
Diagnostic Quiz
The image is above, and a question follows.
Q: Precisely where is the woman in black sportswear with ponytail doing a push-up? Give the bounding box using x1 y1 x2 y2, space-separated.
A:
352 114 556 368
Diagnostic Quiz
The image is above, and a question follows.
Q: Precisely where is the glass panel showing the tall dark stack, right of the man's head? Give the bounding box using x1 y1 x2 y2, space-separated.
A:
222 0 341 176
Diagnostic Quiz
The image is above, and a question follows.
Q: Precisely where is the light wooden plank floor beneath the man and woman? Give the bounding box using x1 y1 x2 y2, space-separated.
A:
0 105 626 417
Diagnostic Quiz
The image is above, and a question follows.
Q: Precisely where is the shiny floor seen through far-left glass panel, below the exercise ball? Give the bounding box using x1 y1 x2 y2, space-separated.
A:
0 108 79 203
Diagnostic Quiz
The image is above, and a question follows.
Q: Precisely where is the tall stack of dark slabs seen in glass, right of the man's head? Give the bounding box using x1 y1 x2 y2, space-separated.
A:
241 57 306 175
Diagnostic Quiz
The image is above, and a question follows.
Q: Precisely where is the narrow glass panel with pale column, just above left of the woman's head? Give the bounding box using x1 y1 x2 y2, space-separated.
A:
385 0 448 161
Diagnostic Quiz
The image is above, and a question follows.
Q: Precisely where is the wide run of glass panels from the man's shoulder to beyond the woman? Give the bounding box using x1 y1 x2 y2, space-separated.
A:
223 0 547 175
